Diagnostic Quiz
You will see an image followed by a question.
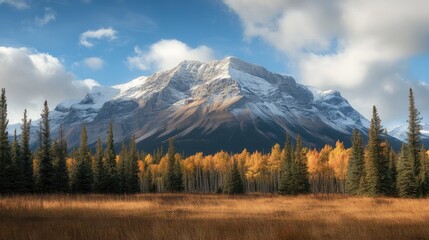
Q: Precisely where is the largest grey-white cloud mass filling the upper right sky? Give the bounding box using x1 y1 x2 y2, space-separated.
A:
224 0 429 122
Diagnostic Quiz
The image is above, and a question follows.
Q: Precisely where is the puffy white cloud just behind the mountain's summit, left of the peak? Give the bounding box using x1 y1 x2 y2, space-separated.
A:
128 39 214 71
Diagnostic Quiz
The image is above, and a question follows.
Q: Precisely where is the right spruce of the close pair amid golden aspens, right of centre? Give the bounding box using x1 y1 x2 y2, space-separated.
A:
292 135 310 194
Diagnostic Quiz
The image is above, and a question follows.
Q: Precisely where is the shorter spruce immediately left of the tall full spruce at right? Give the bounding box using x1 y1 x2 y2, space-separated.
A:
346 129 364 195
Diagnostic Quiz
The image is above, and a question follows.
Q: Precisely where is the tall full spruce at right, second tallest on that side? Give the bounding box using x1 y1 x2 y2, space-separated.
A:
365 106 386 196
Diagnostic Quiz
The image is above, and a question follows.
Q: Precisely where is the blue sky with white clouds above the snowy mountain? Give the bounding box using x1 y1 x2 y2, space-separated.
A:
0 0 429 125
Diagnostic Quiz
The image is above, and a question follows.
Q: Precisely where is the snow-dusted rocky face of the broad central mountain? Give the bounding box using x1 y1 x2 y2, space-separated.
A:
40 57 369 154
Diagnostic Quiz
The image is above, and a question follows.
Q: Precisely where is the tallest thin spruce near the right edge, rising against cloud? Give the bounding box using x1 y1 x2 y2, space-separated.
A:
407 88 422 177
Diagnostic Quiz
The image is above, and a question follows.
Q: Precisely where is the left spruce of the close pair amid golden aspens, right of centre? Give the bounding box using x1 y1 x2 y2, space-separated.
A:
279 136 293 194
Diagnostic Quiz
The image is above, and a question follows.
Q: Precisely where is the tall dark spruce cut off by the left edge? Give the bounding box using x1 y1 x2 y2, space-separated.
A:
0 88 14 194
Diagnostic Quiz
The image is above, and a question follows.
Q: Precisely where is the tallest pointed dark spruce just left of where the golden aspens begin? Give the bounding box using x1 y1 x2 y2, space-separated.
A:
102 122 120 193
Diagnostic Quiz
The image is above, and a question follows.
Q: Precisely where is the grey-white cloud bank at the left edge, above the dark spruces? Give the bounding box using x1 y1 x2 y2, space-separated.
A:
0 47 98 123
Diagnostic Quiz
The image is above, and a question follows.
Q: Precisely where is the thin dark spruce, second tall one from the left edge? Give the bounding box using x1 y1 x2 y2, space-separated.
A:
21 110 34 193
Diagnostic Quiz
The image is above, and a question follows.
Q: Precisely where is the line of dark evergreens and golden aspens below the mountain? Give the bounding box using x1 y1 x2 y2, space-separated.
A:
0 89 429 197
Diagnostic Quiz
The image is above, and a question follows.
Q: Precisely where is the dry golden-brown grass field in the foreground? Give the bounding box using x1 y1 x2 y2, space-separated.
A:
0 194 429 240
